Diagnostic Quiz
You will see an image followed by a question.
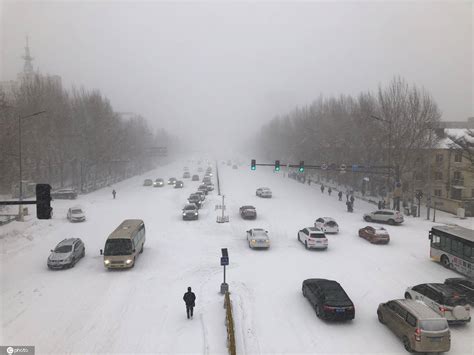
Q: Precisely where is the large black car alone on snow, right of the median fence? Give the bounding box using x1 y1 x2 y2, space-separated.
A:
302 279 355 320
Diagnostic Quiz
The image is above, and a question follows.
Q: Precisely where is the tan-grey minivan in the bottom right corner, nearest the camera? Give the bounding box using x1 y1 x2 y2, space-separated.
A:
377 300 451 353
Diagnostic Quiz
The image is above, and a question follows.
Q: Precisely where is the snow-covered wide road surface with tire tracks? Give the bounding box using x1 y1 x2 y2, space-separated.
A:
0 160 474 354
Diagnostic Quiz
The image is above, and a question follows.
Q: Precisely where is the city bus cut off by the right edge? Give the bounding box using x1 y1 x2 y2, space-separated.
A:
429 225 474 277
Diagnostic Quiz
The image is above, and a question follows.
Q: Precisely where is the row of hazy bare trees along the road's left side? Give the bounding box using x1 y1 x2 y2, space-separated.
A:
0 75 173 193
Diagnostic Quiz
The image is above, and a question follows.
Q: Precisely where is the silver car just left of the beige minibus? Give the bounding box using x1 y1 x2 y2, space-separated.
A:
48 238 86 269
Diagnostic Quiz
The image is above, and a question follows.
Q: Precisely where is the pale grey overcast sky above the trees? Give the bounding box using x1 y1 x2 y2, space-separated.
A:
0 0 474 150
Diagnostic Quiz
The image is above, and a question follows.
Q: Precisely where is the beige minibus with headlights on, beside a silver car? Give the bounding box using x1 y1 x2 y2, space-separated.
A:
100 219 145 269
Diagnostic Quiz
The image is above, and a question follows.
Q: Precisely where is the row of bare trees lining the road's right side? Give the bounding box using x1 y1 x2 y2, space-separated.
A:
257 77 441 197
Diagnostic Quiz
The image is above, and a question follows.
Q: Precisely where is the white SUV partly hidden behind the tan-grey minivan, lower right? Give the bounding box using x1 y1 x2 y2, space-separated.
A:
405 283 471 323
